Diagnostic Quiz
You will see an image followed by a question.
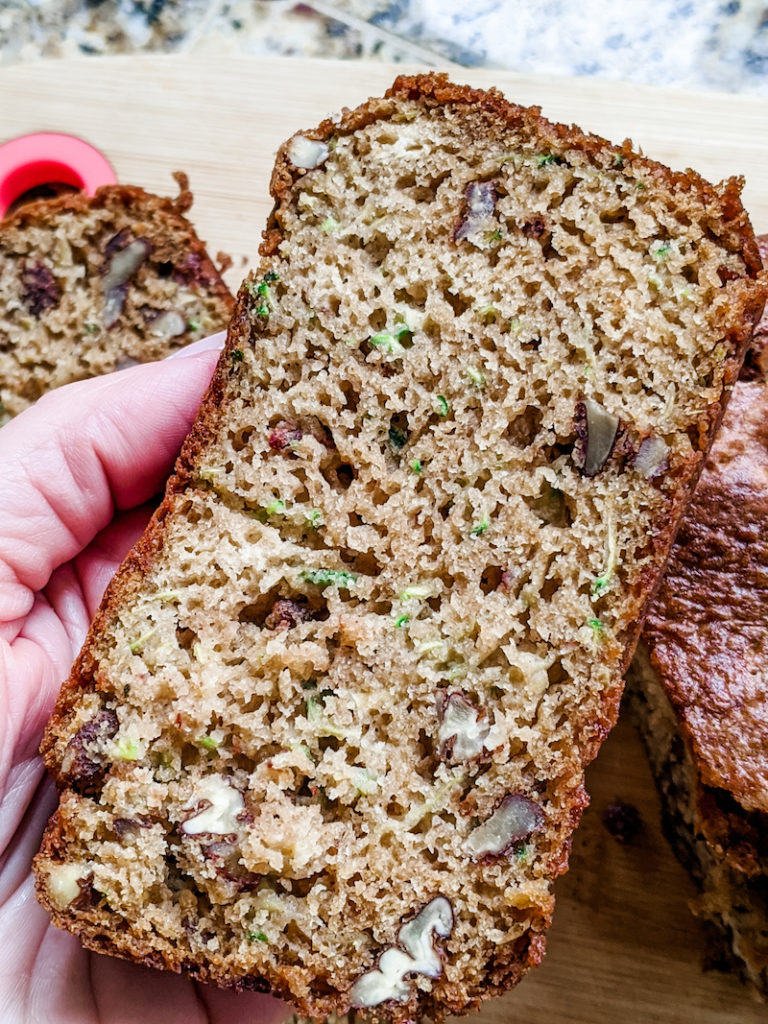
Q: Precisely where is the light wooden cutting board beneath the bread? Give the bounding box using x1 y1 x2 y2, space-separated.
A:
0 56 768 1024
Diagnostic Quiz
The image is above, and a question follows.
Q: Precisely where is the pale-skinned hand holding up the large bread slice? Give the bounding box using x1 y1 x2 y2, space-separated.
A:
0 336 290 1024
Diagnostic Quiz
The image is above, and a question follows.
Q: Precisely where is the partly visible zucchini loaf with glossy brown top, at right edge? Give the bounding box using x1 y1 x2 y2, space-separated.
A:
628 239 768 995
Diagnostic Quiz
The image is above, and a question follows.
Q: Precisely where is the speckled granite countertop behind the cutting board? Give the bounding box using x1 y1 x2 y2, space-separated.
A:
0 0 768 95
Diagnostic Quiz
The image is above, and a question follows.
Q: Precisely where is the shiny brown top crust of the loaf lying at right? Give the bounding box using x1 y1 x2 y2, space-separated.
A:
644 381 768 811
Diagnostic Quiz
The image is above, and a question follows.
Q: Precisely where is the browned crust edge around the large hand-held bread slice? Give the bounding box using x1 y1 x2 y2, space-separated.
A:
38 75 766 1021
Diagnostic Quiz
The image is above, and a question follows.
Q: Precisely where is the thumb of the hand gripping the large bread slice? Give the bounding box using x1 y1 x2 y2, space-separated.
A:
0 339 218 639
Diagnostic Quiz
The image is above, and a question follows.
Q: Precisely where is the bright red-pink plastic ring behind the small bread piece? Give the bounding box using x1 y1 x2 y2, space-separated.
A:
0 132 117 218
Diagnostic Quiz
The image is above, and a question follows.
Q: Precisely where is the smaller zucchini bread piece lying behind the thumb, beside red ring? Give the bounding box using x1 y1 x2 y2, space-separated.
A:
0 174 233 423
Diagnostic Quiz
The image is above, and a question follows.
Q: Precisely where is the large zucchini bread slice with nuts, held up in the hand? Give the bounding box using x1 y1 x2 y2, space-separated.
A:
37 76 766 1021
